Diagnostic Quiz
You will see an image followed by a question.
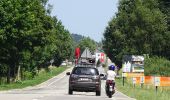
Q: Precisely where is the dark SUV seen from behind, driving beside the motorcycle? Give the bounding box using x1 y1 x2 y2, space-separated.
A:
67 66 103 96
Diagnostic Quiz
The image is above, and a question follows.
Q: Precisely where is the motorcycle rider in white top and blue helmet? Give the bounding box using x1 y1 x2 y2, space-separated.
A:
106 65 116 94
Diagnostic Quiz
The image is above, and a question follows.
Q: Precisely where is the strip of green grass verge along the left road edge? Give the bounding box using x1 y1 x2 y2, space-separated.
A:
0 67 67 90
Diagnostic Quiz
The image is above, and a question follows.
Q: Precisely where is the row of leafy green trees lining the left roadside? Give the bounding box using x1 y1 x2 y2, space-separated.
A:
0 0 73 83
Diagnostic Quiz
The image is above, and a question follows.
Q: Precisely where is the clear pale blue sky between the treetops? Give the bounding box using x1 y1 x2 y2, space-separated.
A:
49 0 119 42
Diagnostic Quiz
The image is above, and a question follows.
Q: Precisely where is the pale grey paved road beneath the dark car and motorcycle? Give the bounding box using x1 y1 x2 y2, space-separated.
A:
0 68 134 100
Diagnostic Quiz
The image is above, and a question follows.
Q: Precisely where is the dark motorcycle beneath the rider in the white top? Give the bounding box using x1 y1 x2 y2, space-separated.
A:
105 80 115 98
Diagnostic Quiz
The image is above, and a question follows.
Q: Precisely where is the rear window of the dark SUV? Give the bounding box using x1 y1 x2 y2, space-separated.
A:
73 67 99 75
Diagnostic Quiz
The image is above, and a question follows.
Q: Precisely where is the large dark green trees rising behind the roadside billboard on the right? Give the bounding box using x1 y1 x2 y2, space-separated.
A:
102 0 170 66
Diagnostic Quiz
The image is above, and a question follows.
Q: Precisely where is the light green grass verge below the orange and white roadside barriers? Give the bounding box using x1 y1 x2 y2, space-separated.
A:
116 78 170 100
